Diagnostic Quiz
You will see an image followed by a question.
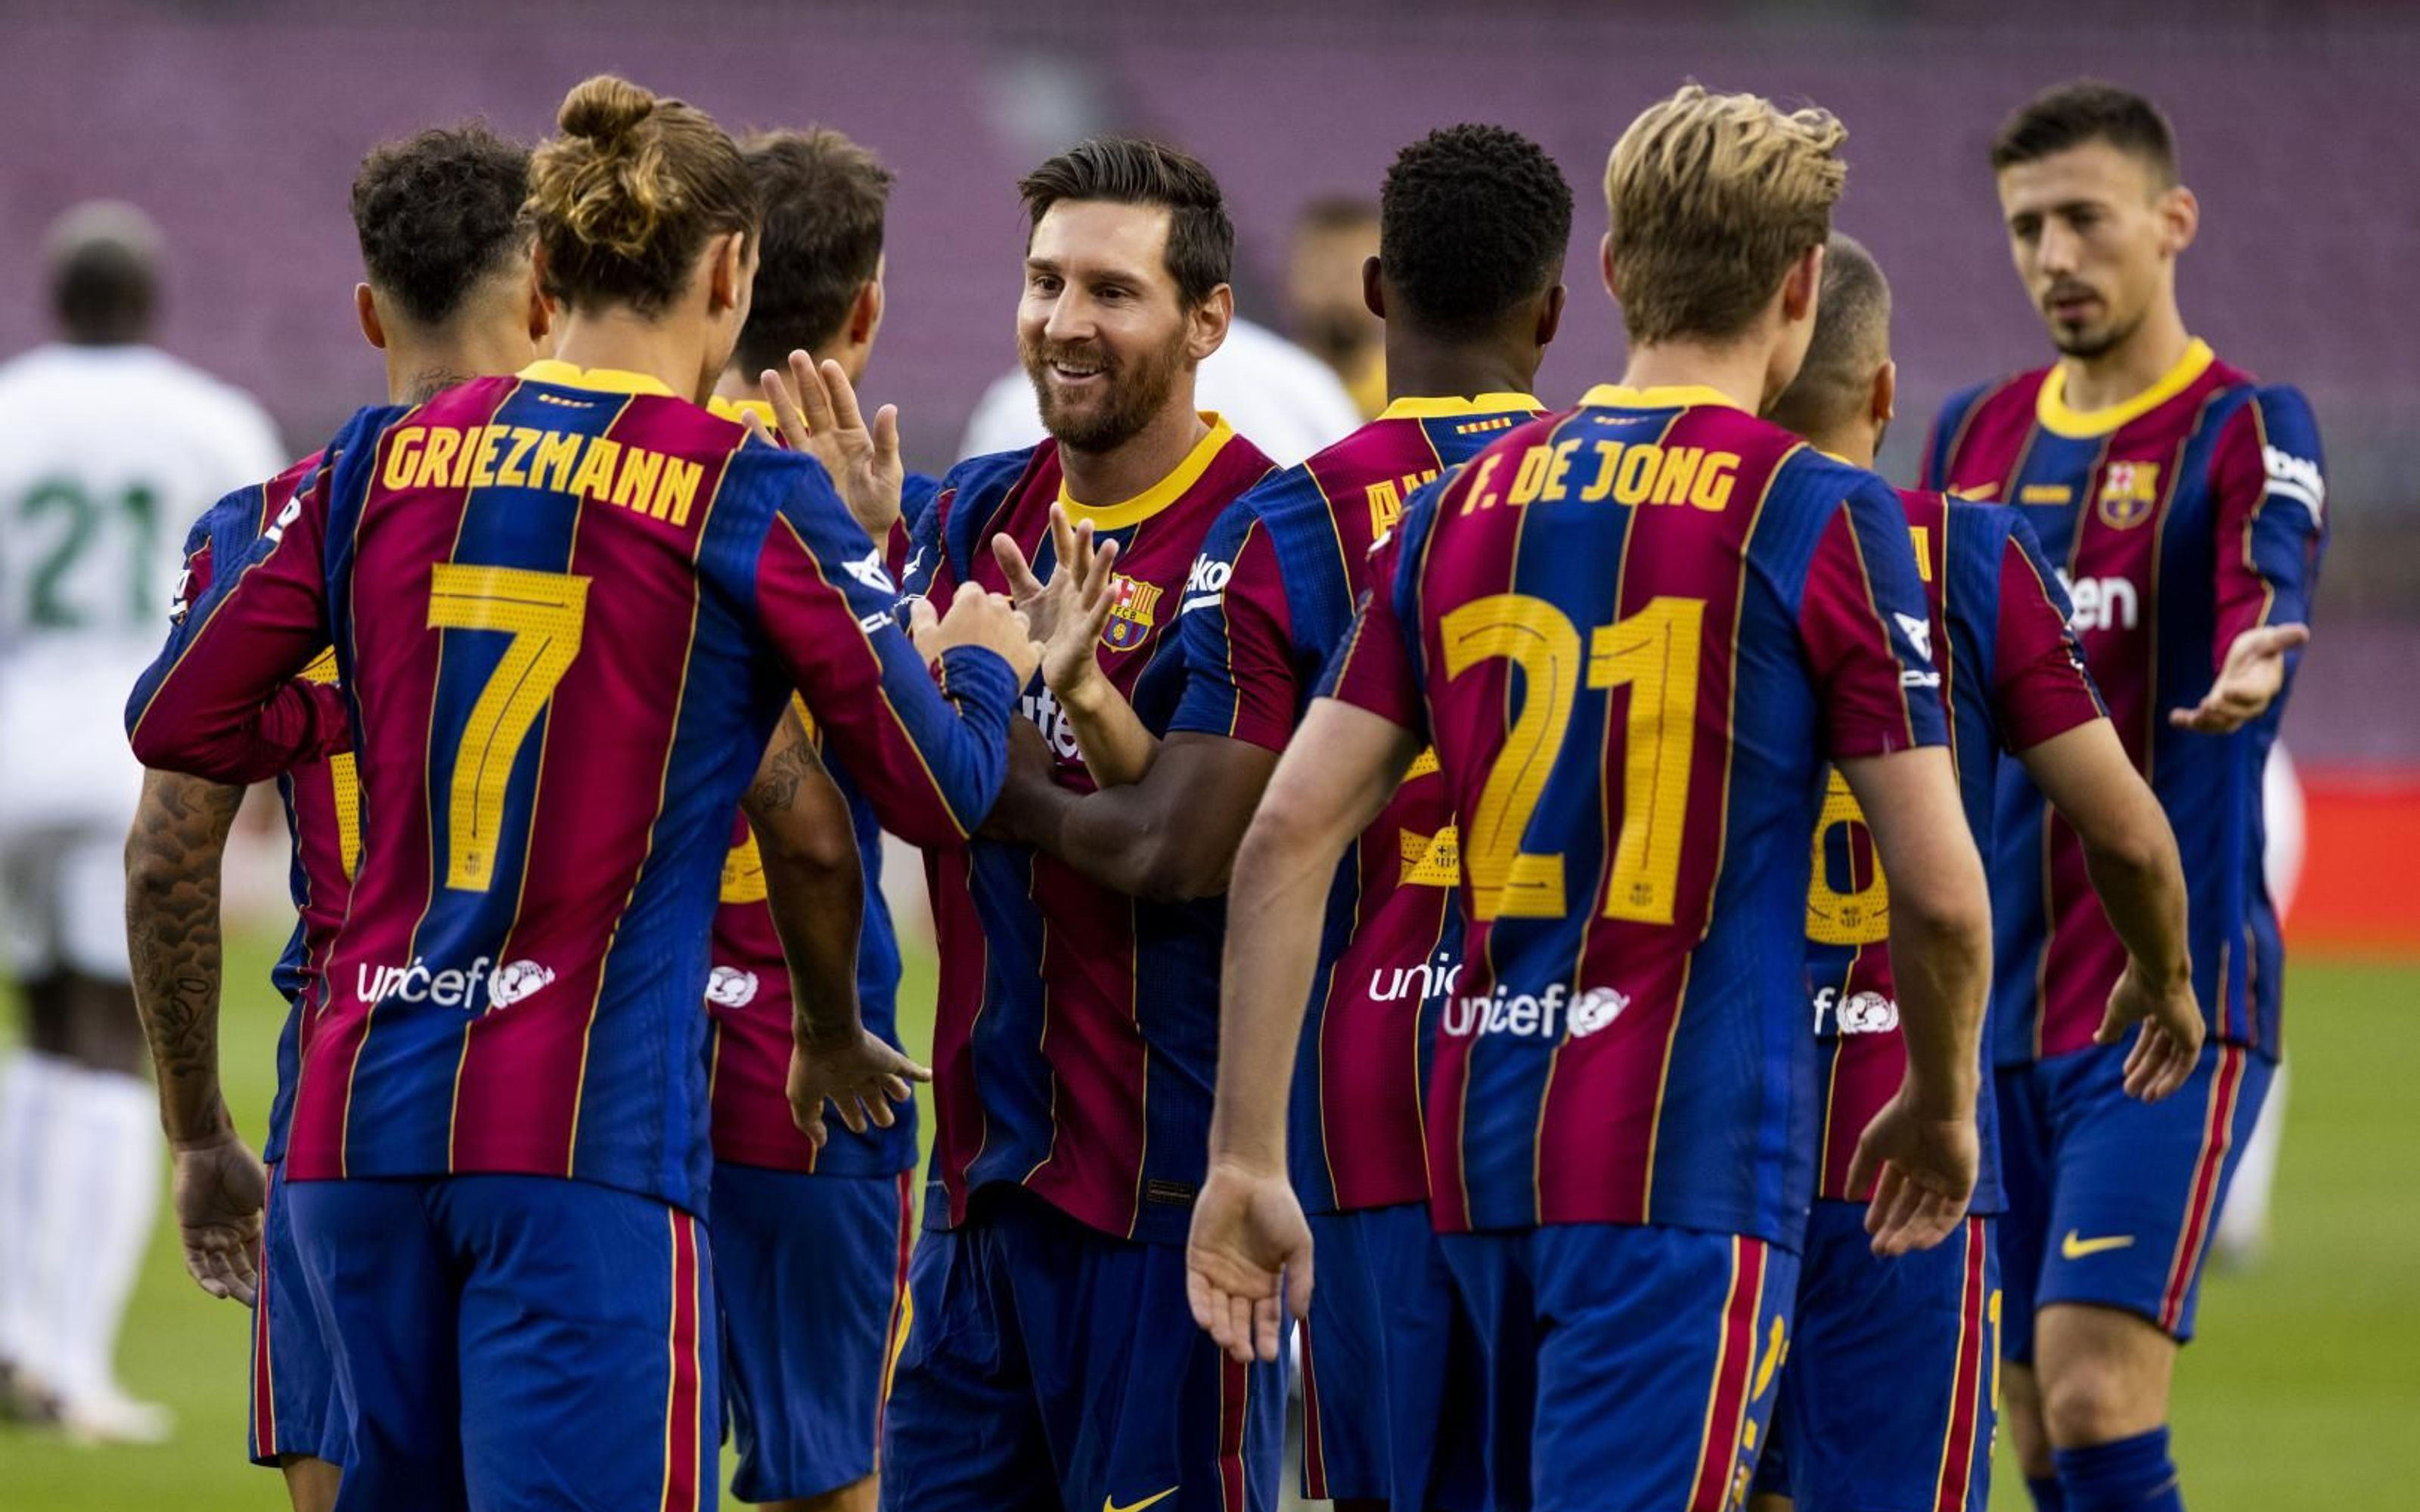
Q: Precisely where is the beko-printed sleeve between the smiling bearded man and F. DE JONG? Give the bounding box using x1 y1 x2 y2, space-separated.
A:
1169 506 1302 750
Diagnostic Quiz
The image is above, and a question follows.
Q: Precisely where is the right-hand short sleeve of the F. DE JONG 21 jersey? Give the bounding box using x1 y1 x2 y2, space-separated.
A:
1798 479 1948 762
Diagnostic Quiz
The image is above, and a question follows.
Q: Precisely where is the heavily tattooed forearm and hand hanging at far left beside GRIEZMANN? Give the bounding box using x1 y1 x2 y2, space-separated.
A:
126 772 266 1306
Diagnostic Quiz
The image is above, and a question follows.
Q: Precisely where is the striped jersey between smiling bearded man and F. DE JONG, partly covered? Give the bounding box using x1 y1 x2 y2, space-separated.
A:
1169 395 1544 1212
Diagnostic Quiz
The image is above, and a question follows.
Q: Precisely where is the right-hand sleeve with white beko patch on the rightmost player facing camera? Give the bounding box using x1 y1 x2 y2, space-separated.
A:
2210 387 2328 670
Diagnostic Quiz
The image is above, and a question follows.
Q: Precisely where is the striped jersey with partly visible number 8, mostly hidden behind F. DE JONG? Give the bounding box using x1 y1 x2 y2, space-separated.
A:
1807 488 2103 1214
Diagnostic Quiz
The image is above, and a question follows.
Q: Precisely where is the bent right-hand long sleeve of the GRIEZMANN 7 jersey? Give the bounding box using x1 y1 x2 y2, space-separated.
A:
752 457 1019 844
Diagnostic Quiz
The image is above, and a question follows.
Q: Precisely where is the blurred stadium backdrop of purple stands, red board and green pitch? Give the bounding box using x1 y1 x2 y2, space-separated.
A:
0 0 2420 1512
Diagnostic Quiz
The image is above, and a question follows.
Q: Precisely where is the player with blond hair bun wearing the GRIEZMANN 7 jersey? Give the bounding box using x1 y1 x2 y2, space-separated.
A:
129 77 1036 1512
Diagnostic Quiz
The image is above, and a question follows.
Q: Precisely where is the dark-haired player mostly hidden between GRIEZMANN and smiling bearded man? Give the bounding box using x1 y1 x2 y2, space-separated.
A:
706 129 936 1512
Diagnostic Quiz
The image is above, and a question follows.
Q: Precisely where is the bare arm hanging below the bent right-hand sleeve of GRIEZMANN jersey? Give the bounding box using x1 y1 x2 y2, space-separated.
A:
740 711 929 1147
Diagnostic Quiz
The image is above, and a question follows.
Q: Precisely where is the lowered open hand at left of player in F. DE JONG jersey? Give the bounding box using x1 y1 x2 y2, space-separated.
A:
1186 1159 1311 1365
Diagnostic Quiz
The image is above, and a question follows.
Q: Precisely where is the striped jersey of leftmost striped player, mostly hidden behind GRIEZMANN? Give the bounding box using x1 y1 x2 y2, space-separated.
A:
177 452 361 1161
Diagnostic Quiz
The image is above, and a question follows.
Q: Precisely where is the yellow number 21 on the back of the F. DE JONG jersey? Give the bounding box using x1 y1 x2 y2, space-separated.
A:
1438 593 1706 924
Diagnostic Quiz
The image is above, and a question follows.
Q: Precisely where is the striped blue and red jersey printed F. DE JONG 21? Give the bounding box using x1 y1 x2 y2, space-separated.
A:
1336 387 1946 1248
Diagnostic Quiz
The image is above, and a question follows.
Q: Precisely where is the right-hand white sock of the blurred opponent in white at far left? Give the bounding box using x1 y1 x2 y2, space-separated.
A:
44 1069 160 1401
